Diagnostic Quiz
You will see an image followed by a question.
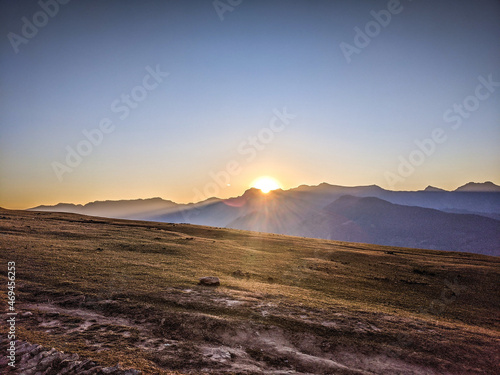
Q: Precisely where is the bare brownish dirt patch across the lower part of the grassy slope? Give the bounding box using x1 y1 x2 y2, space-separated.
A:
1 291 442 374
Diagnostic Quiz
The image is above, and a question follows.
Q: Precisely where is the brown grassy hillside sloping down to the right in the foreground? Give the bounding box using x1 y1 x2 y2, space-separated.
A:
0 210 500 374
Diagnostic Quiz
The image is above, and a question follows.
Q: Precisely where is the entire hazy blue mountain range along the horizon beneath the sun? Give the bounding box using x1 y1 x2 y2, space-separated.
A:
31 182 500 256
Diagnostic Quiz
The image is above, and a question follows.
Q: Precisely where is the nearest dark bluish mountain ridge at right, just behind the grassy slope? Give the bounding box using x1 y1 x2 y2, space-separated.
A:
294 196 500 255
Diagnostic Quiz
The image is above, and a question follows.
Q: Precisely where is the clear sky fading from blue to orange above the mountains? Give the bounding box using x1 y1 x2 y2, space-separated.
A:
0 0 500 209
